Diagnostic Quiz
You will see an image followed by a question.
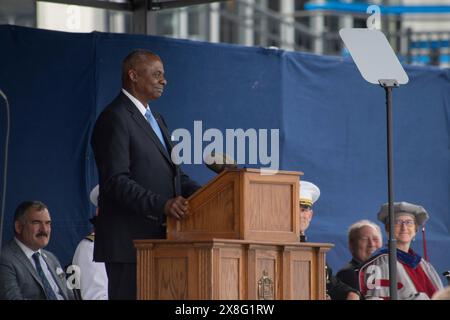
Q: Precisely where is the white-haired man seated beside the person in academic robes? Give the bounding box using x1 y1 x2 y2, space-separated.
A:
336 220 383 290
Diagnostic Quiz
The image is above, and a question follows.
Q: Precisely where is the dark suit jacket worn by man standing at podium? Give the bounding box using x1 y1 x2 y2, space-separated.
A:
91 92 200 263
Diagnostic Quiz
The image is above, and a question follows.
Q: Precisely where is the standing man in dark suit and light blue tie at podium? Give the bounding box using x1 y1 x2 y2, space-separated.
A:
91 50 200 299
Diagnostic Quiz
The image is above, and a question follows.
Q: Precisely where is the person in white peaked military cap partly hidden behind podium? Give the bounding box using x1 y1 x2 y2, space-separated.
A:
300 181 360 300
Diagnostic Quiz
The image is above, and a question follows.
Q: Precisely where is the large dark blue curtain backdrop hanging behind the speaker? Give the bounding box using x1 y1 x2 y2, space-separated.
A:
0 26 450 280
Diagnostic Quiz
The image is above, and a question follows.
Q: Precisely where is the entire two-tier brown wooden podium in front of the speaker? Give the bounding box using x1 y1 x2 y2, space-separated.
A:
134 169 332 300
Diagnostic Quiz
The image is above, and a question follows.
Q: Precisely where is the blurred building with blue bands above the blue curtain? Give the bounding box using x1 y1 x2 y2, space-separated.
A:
0 0 450 67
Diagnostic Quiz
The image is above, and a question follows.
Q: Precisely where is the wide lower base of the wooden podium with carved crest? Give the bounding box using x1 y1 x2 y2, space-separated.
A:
135 239 332 300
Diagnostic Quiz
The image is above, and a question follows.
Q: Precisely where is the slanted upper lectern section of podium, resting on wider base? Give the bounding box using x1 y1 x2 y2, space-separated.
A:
167 169 302 242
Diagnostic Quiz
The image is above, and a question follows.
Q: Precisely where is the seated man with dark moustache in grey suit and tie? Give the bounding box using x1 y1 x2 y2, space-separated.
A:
0 201 73 300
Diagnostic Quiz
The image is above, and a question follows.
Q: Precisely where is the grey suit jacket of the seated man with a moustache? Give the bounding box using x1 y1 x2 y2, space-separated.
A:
0 240 73 300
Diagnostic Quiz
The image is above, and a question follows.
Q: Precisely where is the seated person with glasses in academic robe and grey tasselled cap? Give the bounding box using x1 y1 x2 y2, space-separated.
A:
359 202 443 300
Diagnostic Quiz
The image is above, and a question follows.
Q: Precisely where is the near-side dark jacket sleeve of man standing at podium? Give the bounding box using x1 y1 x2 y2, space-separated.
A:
92 112 168 217
